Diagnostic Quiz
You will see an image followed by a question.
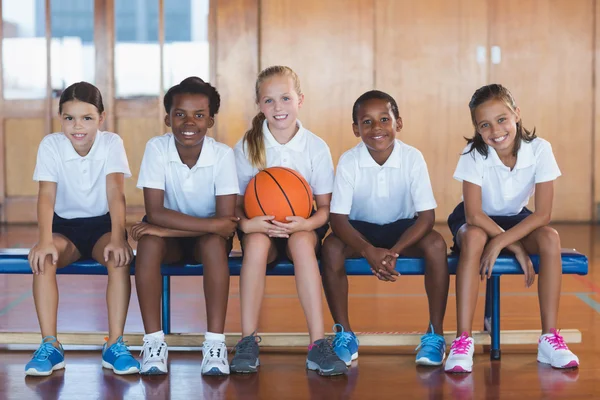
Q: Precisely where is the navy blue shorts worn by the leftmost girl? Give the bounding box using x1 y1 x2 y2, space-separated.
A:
52 213 112 258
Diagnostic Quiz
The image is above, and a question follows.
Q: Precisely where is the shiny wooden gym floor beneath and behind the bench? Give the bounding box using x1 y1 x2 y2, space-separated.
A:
0 225 600 400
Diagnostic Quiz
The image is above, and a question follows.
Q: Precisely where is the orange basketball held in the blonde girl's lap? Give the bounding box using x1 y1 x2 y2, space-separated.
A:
244 167 313 222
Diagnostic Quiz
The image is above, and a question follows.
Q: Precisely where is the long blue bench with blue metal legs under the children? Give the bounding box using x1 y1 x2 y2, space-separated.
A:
0 249 588 360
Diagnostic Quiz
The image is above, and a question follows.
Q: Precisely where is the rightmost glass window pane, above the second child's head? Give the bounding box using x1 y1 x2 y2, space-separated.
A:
163 0 210 91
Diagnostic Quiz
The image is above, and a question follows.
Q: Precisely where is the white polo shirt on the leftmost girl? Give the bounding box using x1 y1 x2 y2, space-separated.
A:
33 131 131 219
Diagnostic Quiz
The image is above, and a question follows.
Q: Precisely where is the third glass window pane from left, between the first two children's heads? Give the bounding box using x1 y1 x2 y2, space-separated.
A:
115 0 159 98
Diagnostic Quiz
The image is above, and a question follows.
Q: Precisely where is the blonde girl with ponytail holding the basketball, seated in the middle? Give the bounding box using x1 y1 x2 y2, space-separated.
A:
231 66 346 376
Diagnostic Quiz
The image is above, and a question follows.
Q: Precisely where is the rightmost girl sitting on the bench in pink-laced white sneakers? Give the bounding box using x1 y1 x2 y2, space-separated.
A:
445 84 579 372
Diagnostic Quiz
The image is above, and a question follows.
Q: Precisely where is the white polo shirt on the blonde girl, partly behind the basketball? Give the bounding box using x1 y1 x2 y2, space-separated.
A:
234 120 334 195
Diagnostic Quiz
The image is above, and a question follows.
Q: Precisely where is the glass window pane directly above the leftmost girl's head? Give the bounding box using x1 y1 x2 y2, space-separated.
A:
50 0 96 97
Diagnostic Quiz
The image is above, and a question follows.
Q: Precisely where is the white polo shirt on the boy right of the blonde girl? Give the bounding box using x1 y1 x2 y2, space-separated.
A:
330 139 437 225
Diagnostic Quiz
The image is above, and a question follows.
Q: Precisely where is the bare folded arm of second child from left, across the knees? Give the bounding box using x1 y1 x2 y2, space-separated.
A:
144 187 238 238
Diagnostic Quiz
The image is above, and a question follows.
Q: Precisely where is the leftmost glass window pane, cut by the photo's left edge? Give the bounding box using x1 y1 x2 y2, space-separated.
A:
2 0 47 99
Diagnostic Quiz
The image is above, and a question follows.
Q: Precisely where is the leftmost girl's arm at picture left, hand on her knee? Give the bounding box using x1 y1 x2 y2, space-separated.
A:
27 181 58 275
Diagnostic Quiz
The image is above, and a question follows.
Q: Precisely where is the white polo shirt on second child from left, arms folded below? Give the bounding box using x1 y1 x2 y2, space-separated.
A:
137 133 239 218
